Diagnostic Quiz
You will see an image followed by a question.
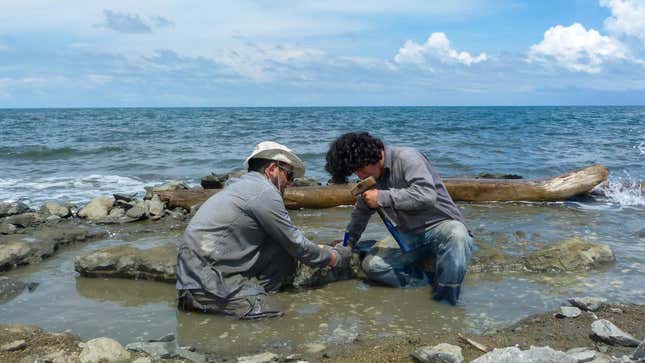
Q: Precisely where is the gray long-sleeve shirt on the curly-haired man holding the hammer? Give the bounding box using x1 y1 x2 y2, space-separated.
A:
347 147 464 241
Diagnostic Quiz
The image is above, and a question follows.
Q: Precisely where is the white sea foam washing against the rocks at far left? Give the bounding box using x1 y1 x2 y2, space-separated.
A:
0 174 186 208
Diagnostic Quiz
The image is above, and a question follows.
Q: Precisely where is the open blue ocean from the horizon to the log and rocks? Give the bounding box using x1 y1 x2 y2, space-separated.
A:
0 107 645 206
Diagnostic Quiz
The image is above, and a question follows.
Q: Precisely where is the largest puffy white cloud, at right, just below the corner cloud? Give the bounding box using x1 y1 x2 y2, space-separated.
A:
528 23 627 73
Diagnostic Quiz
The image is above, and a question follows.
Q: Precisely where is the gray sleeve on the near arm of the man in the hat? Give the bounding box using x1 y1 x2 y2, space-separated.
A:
250 191 331 267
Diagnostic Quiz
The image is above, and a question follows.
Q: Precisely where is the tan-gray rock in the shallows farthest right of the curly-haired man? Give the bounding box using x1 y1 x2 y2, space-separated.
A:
522 237 614 272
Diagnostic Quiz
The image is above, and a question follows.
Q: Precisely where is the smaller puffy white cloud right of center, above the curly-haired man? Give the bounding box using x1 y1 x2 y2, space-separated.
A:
394 33 488 69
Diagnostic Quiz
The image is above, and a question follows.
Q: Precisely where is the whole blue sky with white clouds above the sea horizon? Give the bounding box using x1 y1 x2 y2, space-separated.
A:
0 0 645 108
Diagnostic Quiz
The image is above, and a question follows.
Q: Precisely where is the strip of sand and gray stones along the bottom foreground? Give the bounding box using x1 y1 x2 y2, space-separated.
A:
0 297 645 363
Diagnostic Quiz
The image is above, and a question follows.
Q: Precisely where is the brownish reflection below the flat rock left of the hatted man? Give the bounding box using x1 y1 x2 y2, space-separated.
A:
76 276 177 306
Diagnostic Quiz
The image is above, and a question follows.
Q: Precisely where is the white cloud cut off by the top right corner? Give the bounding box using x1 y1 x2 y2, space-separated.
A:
600 0 645 42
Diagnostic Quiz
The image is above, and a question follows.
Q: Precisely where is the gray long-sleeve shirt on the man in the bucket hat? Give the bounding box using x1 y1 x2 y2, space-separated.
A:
177 172 331 300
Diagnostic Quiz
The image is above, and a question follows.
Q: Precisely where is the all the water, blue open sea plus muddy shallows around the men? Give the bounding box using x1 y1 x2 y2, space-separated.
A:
0 107 645 356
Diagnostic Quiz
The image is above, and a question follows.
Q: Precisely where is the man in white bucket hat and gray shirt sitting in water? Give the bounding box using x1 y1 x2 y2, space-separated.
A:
177 141 351 319
